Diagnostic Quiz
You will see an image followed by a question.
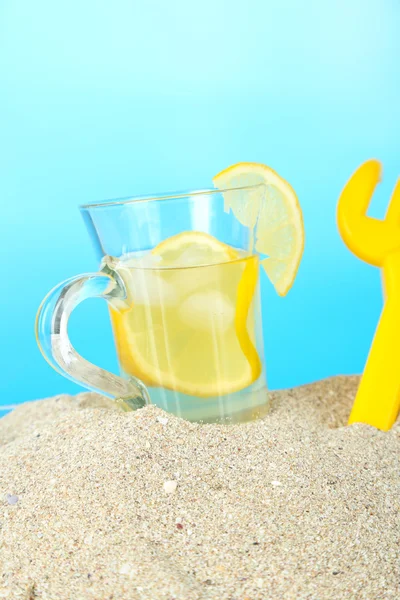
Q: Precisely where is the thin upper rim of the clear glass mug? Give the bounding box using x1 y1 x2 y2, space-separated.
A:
79 183 265 210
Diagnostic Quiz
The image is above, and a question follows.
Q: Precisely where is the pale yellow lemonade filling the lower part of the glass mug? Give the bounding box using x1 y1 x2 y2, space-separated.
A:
110 246 267 422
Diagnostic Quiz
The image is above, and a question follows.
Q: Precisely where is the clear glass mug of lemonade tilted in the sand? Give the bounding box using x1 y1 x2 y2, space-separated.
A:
36 185 268 423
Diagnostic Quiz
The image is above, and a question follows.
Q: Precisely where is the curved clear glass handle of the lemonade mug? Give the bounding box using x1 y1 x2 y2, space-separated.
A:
35 267 150 411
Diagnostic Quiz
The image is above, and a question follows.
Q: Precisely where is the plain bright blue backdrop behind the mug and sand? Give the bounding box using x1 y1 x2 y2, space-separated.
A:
0 0 400 404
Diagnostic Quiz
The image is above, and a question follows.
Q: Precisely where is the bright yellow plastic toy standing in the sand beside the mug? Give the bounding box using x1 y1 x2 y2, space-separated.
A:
337 160 400 431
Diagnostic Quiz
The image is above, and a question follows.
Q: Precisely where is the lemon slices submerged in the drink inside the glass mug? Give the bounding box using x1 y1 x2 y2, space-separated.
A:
111 232 261 398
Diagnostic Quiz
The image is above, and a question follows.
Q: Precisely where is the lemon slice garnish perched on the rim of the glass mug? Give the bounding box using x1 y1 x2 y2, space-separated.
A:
213 163 304 296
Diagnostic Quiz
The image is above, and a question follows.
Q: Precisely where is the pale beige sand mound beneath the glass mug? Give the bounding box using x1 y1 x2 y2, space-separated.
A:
0 377 400 600
